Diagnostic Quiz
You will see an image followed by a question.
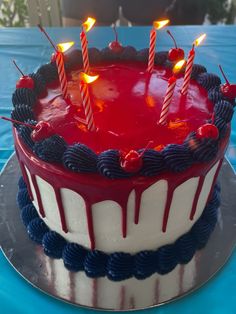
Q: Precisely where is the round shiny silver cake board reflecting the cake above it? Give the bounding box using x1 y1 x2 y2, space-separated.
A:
0 156 236 310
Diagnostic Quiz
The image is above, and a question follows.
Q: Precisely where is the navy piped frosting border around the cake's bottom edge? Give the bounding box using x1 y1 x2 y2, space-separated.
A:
17 177 220 281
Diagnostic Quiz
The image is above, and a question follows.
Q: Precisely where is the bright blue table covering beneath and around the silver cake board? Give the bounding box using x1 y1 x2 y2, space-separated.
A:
0 26 236 314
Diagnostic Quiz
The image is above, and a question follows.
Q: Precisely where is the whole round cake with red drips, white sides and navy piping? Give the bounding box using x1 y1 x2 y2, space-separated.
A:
12 31 234 281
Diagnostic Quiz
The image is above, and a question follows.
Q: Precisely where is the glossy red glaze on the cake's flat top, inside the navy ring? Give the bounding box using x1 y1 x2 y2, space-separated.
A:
34 62 213 152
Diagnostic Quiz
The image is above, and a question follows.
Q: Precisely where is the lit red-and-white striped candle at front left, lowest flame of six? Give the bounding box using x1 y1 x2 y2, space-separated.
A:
79 72 98 131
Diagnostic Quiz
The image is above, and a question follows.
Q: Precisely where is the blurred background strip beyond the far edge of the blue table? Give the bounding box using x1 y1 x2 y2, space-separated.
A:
0 0 236 27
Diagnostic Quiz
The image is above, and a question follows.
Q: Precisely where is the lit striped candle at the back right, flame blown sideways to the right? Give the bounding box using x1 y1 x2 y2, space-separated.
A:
148 20 169 73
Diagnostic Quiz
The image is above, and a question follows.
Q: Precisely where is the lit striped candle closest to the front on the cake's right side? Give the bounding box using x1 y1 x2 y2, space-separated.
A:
159 60 185 125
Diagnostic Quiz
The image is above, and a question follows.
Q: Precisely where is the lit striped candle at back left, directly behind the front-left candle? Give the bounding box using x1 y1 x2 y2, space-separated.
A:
80 17 96 74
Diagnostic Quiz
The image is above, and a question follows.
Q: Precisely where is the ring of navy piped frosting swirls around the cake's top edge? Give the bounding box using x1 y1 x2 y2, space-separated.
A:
12 46 234 179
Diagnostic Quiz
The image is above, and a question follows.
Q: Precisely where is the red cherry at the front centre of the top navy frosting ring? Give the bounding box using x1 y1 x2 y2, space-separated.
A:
120 141 153 173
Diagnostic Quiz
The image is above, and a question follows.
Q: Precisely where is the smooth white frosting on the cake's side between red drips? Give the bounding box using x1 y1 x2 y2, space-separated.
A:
26 162 219 253
